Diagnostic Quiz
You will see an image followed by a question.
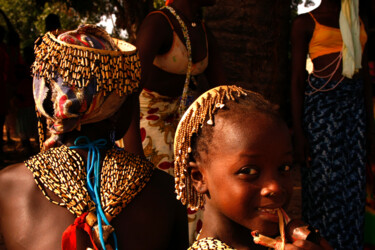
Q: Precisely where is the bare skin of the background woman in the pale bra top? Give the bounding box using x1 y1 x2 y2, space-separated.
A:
135 0 226 97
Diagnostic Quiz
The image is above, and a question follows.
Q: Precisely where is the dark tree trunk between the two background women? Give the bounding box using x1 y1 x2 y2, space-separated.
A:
204 0 291 116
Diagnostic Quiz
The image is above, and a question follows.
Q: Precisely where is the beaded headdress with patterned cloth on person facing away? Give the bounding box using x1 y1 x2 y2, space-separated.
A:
32 25 141 149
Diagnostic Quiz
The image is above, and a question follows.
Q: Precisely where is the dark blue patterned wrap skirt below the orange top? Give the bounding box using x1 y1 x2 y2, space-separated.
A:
301 76 366 249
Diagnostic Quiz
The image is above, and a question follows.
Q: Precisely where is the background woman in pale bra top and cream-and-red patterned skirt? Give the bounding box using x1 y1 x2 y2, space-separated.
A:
133 0 225 240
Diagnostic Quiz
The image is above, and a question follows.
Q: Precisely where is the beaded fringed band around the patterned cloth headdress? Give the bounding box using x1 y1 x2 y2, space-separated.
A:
32 25 141 96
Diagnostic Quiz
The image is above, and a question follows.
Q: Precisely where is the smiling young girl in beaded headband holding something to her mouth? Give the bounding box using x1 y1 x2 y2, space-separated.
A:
174 86 328 249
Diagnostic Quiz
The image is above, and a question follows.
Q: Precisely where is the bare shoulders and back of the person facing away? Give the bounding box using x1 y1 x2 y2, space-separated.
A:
0 95 188 250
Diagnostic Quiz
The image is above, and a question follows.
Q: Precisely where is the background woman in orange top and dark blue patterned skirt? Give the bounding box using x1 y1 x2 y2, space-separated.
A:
291 0 372 249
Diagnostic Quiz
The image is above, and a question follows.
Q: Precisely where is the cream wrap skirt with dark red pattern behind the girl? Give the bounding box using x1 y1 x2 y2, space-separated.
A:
139 89 202 243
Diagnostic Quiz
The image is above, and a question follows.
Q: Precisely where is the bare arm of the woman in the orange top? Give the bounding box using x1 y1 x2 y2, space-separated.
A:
291 14 314 163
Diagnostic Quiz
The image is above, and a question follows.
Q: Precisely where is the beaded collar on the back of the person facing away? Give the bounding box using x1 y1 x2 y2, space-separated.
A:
25 145 154 249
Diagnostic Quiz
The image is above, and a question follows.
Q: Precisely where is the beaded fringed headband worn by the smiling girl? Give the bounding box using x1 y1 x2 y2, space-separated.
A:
174 85 254 210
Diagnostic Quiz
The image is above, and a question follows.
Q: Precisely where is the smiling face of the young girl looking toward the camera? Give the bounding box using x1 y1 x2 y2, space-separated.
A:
198 113 293 236
